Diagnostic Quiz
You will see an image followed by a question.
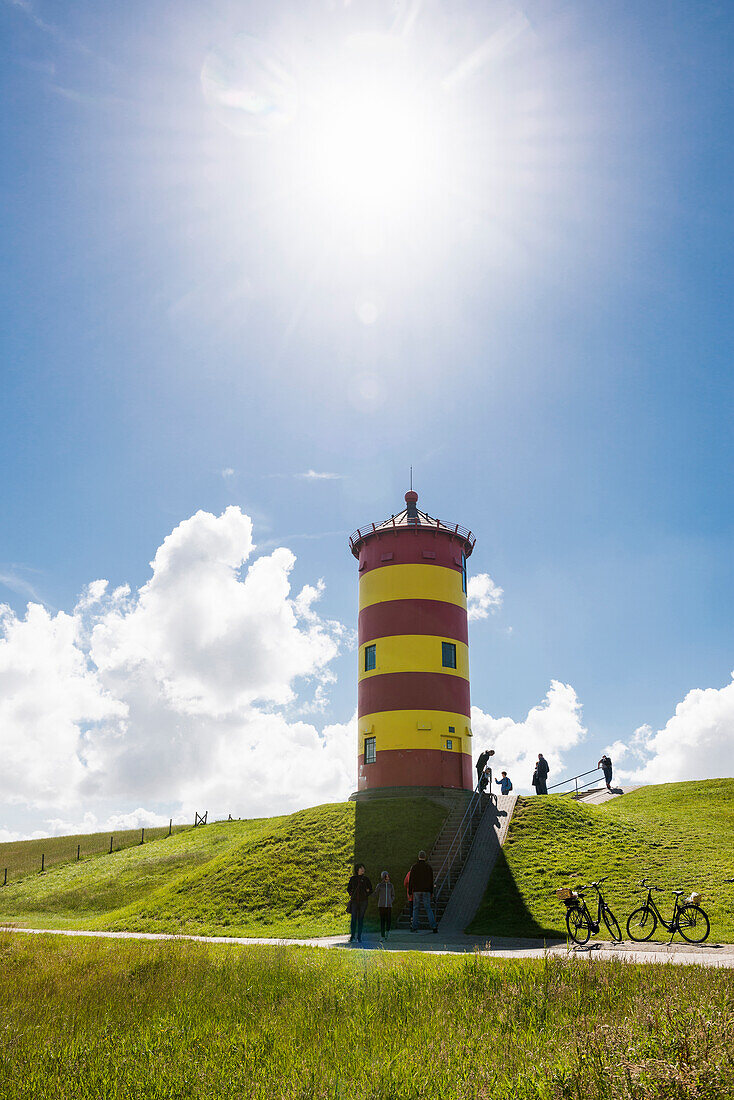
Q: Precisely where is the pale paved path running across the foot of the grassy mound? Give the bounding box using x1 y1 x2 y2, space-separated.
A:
0 925 734 968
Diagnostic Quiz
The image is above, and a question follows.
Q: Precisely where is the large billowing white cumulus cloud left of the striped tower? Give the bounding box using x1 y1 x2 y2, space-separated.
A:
0 507 354 832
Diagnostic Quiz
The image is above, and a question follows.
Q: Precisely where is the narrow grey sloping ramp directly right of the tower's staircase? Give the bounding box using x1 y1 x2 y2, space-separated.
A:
441 794 517 935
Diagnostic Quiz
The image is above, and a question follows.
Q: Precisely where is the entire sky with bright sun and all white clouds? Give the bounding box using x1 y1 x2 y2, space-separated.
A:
0 0 734 838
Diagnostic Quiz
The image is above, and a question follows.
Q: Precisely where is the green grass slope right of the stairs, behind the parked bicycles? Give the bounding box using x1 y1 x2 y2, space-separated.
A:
468 779 734 943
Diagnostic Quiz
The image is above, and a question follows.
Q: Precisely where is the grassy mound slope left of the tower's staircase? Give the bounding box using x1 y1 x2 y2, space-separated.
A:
0 799 448 936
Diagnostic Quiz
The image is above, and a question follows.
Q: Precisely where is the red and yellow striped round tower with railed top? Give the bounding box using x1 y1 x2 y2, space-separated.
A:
350 491 474 795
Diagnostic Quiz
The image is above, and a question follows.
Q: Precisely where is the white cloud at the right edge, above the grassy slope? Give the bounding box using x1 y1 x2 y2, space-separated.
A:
610 673 734 783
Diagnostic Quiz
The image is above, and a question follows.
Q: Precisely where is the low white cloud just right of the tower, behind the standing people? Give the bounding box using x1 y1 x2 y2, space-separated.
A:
471 680 587 791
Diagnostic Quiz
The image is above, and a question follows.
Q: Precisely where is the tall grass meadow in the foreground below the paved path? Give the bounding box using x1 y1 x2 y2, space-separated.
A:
0 934 734 1100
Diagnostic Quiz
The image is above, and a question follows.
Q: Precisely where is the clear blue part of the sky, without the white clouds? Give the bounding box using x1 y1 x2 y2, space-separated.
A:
0 0 734 829
